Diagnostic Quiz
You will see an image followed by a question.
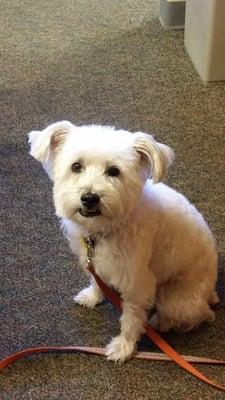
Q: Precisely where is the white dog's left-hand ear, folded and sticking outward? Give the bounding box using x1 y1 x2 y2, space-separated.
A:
28 121 73 163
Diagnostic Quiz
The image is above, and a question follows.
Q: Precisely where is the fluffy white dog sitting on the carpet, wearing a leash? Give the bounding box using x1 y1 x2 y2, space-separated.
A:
29 121 219 361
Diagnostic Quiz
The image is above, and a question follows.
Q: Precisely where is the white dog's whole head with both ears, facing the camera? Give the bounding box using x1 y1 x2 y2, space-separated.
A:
29 121 173 232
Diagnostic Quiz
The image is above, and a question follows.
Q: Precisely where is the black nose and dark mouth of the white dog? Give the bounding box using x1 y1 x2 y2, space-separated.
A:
79 192 101 218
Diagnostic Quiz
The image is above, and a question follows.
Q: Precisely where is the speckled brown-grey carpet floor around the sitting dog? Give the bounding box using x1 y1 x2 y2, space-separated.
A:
0 0 225 400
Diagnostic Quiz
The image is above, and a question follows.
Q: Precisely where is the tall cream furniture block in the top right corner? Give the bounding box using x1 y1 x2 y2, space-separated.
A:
184 0 225 82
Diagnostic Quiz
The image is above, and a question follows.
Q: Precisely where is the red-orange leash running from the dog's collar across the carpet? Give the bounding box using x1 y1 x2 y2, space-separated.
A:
0 264 225 391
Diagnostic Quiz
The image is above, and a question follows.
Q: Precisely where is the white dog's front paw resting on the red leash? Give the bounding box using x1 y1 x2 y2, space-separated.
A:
106 335 136 362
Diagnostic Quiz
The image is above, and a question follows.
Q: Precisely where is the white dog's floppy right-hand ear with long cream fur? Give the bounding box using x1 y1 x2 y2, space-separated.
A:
133 132 174 183
